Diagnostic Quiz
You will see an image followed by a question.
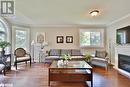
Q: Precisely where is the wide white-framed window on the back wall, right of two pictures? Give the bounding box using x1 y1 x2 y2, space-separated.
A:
80 29 104 47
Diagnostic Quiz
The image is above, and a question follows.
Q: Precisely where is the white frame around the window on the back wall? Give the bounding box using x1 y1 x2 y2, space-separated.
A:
79 28 105 48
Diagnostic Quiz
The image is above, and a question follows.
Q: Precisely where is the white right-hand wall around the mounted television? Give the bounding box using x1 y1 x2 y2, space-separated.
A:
107 15 130 64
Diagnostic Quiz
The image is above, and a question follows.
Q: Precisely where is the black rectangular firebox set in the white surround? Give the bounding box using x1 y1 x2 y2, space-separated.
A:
118 54 130 73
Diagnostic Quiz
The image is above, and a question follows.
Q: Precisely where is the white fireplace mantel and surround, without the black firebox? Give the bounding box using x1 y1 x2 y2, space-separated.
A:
114 45 130 78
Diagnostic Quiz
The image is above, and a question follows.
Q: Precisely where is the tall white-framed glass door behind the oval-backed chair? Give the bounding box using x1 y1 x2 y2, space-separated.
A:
12 26 30 52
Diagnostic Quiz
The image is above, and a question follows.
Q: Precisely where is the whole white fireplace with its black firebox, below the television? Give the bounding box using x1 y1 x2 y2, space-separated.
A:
114 45 130 78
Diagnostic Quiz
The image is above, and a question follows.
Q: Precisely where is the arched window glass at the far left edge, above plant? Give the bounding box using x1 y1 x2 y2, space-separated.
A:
0 20 6 41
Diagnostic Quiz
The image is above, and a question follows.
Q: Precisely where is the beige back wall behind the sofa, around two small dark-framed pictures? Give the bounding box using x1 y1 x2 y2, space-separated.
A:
31 26 105 52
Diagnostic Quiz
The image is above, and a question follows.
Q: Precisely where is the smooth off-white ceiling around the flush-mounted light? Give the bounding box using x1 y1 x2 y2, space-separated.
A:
5 0 130 26
